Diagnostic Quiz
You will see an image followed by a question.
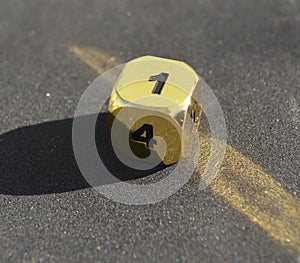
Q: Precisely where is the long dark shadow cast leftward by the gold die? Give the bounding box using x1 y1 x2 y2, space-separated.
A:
0 113 163 195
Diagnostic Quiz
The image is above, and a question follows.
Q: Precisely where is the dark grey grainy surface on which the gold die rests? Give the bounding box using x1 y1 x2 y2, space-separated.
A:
0 0 300 262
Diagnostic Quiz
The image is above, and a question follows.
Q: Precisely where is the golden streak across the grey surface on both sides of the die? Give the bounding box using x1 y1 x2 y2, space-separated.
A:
69 46 300 253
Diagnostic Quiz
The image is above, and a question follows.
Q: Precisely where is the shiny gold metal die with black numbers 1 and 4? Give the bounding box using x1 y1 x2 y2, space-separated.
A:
108 56 201 165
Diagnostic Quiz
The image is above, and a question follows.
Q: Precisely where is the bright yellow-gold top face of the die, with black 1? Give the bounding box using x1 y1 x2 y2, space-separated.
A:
114 56 199 112
